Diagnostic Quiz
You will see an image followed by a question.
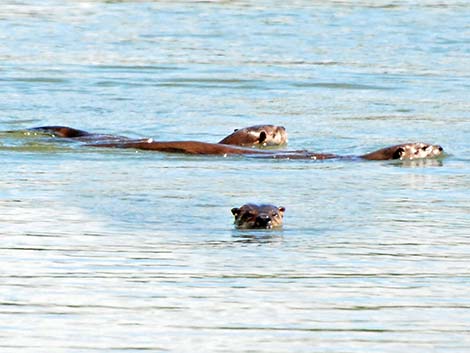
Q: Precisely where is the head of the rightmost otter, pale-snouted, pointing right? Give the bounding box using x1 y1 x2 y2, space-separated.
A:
361 142 444 161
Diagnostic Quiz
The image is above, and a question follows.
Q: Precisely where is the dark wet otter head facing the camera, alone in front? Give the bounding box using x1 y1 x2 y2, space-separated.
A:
232 203 286 229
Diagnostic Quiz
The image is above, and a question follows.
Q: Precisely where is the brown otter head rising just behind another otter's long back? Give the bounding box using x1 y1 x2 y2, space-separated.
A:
219 125 287 147
